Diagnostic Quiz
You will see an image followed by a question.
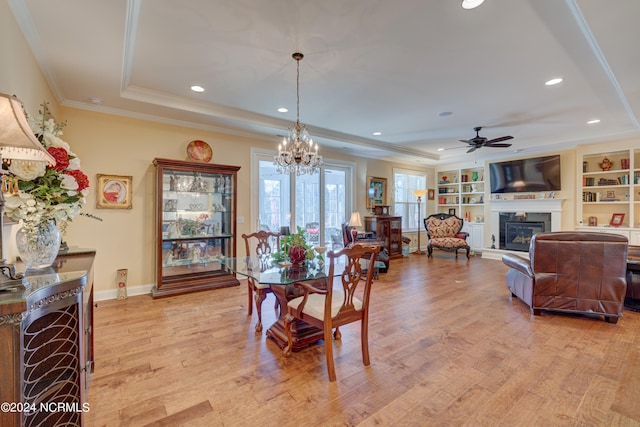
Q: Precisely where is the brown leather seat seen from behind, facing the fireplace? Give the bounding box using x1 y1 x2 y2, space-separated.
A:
502 231 628 323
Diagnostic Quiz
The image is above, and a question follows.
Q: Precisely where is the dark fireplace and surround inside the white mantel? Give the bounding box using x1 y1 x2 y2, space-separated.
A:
499 212 551 252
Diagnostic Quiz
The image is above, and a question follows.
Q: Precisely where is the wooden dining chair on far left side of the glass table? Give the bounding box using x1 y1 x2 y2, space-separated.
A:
242 230 280 332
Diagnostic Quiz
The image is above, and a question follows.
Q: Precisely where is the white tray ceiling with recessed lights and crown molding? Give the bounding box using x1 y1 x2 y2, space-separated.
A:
8 0 640 165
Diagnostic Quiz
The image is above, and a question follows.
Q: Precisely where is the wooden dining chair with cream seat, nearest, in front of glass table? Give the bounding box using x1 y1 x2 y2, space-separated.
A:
283 244 380 381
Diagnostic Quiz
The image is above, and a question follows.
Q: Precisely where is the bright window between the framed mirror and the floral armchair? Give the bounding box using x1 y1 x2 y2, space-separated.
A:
393 168 427 231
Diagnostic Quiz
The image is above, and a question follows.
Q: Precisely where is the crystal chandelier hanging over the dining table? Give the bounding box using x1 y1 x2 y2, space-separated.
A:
273 52 322 176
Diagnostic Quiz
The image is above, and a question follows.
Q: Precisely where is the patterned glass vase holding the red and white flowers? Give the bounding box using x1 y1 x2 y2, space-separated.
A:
16 222 61 269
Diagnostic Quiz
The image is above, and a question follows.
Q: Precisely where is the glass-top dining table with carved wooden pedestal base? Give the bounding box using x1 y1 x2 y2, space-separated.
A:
222 256 384 351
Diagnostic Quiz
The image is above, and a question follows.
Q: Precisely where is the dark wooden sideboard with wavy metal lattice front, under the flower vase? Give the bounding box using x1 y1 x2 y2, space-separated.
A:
0 250 95 427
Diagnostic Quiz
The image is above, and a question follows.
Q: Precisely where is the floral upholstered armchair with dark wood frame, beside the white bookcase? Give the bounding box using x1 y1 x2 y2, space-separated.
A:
424 213 470 259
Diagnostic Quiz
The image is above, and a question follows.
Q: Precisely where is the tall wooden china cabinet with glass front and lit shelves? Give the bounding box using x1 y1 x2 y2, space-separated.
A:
152 159 240 298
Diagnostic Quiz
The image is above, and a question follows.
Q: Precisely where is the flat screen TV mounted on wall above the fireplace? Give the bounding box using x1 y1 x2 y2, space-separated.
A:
489 155 561 193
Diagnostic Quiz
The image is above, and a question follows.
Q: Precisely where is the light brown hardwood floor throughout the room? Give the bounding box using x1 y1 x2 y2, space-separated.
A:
88 251 640 426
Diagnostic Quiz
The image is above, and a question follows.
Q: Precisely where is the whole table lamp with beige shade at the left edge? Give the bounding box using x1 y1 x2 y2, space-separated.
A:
0 93 56 289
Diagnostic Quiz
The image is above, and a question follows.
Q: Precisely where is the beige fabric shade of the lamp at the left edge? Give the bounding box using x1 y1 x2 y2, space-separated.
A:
0 93 56 166
